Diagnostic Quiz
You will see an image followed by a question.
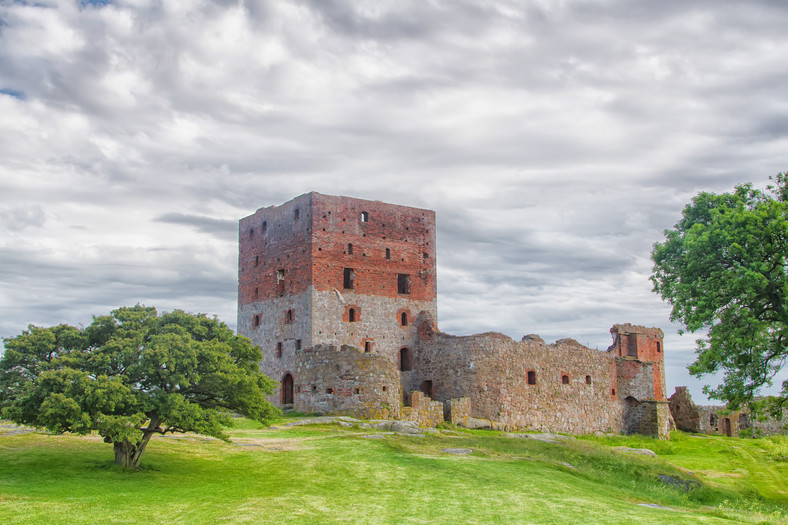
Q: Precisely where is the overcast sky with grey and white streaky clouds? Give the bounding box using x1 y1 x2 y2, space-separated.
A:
0 0 788 401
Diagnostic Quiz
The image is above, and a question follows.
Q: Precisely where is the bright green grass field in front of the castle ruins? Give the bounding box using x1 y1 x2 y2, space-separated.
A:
0 420 788 524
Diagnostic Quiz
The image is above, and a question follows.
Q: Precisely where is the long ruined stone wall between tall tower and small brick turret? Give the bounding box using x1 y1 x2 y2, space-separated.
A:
412 333 622 434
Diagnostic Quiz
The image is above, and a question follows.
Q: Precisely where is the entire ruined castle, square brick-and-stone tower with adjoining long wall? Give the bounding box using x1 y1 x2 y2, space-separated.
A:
238 193 671 437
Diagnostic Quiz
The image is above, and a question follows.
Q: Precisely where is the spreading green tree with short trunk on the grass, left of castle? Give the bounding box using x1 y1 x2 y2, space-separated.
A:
0 305 278 468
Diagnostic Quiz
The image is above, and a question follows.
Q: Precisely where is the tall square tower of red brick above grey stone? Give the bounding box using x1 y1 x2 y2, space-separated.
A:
238 192 437 406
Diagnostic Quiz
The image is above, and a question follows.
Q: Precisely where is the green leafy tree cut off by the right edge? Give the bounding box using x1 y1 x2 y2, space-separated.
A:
651 173 788 412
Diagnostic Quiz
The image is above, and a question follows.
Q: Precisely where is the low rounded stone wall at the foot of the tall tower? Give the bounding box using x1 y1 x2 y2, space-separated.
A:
293 345 401 419
